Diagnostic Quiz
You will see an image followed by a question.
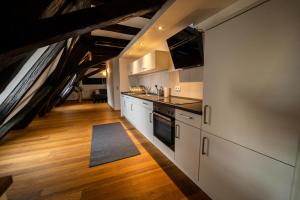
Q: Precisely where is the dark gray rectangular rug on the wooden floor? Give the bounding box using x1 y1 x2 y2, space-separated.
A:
90 122 140 167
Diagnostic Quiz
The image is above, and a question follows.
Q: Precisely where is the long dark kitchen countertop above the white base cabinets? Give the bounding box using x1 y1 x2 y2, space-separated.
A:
121 92 202 115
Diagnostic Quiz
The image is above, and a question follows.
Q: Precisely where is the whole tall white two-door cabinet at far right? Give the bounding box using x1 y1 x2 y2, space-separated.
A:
199 0 300 200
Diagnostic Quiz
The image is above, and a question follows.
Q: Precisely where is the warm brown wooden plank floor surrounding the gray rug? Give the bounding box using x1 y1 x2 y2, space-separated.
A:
0 103 208 200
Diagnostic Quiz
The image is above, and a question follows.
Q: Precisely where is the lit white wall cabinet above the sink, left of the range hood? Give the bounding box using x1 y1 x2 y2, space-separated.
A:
128 51 171 75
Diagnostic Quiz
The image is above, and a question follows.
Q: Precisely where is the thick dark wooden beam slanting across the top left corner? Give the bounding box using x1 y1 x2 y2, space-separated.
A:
0 0 165 62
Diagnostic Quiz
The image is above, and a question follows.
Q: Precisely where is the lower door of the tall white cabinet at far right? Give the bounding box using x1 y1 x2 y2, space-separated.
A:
199 131 294 200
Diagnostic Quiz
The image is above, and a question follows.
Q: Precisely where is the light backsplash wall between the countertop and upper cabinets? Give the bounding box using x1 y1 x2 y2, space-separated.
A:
129 67 203 99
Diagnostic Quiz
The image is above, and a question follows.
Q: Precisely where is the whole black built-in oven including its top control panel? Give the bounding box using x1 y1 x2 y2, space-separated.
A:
153 103 175 151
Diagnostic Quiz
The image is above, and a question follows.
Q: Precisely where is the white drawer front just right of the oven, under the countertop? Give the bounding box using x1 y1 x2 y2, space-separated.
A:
175 109 201 128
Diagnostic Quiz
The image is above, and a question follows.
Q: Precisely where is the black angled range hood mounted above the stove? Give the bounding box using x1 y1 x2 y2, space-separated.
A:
167 27 204 69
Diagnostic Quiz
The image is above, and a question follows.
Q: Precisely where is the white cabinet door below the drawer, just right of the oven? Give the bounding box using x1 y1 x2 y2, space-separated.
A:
175 121 201 182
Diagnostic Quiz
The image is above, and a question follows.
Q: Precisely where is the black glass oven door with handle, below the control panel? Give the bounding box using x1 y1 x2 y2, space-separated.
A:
153 112 175 150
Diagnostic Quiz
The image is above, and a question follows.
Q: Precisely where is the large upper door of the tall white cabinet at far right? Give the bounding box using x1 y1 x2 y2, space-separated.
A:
202 0 300 166
